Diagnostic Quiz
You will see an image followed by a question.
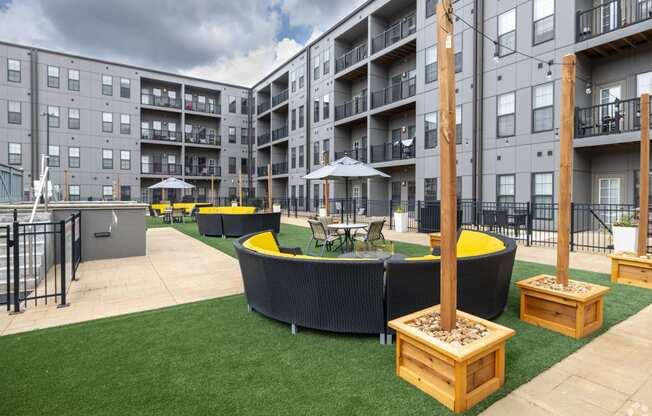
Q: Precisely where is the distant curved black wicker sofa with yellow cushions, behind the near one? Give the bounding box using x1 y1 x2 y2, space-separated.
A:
197 209 281 237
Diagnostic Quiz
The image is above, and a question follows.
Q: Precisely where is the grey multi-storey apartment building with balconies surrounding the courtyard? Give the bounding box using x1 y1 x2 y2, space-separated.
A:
0 0 652 208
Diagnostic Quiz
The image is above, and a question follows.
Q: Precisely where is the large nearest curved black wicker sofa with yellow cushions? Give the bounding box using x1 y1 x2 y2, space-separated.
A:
234 232 516 342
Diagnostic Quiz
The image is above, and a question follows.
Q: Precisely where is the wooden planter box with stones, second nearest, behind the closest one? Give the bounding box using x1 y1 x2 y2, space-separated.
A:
516 275 610 339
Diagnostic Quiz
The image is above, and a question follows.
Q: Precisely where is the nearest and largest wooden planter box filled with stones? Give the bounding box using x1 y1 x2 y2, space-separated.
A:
389 305 515 412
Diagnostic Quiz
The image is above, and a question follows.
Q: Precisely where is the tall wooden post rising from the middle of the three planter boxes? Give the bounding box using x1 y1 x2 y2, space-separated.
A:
557 55 576 286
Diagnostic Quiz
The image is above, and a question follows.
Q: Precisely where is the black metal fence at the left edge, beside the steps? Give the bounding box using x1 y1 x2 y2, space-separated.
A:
0 211 82 313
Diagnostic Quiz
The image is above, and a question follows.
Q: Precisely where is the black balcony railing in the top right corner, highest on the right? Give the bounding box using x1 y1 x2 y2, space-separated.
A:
577 0 652 42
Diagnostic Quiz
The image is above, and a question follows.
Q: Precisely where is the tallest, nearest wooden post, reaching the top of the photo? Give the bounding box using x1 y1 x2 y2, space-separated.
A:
437 0 457 331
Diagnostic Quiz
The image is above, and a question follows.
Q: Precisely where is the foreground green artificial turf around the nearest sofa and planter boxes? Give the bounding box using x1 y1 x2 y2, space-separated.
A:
0 221 652 415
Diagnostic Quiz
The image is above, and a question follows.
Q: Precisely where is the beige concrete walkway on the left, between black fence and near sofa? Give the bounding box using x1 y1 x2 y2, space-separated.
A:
0 228 243 335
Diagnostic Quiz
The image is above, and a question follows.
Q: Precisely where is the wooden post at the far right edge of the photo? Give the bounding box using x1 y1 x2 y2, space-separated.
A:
637 94 650 256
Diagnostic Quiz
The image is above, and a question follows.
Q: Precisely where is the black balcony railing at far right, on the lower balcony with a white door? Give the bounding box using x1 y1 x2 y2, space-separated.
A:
575 98 652 138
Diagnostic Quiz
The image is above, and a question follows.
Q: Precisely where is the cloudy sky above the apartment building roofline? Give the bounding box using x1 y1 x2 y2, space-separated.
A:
0 0 364 86
